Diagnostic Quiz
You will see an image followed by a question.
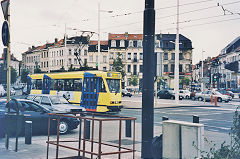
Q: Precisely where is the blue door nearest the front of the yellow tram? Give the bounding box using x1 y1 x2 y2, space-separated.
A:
81 73 100 111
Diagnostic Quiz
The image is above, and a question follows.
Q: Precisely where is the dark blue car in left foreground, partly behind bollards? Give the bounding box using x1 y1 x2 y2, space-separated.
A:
0 99 79 135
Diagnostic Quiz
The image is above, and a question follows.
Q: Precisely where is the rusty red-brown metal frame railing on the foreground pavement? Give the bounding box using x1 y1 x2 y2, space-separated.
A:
46 112 136 159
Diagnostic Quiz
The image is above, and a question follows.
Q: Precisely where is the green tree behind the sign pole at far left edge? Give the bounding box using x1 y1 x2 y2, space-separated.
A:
0 64 17 84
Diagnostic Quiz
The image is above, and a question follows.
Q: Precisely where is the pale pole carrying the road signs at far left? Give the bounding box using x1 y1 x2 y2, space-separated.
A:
5 2 11 149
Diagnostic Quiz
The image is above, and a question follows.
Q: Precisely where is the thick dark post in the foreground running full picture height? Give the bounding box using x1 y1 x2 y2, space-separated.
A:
141 0 155 158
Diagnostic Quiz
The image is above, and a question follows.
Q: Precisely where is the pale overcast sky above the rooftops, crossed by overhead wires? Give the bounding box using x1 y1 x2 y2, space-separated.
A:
0 0 240 64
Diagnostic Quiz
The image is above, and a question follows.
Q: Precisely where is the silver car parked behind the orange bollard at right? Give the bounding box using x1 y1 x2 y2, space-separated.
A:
195 90 232 103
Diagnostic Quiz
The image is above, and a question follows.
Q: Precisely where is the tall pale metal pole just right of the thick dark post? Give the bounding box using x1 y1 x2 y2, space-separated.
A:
174 0 179 104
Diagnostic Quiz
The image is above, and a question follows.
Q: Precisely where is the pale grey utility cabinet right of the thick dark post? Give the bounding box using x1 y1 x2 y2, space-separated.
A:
163 120 204 159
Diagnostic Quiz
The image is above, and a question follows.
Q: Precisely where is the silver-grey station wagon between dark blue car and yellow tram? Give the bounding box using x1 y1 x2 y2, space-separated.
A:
26 94 86 112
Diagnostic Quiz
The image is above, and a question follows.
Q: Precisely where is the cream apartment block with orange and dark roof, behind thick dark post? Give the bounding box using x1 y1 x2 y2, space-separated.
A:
108 33 192 88
